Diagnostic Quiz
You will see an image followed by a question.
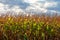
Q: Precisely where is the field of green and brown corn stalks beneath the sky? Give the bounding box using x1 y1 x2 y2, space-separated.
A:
0 16 60 40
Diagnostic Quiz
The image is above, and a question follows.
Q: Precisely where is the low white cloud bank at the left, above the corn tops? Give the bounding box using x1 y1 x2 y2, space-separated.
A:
0 3 24 14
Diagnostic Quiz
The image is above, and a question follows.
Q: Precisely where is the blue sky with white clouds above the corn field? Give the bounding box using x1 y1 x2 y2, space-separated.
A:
0 0 60 14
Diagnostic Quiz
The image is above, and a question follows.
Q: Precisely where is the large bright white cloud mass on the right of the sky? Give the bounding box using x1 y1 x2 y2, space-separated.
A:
26 0 57 13
